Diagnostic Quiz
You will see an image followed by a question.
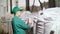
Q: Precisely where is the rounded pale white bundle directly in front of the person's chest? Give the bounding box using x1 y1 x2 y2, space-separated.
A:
21 11 33 27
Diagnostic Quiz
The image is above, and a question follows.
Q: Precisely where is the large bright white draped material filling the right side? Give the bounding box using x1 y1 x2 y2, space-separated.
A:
38 7 60 34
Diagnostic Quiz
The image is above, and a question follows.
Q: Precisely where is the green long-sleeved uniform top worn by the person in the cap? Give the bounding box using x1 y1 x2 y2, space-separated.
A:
12 16 30 34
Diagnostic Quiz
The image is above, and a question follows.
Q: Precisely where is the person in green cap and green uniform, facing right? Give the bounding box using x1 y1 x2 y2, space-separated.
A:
12 7 30 34
